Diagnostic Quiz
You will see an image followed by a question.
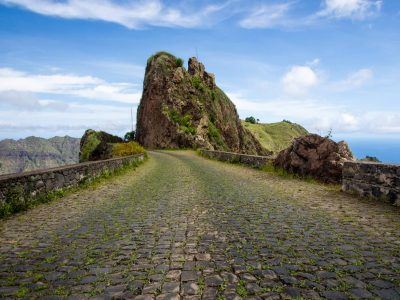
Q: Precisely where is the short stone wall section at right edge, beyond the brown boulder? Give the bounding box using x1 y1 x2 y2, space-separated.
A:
342 162 400 206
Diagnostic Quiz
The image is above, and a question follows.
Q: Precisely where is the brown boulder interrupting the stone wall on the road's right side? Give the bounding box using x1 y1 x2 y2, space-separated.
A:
274 134 354 183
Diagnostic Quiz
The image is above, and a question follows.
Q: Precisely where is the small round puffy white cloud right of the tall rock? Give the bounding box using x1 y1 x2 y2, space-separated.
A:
282 66 318 96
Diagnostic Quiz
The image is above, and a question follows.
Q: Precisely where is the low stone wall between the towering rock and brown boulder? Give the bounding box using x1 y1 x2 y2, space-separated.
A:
200 149 273 168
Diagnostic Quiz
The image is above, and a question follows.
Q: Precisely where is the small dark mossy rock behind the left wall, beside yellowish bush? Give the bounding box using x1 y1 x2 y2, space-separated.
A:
79 129 123 162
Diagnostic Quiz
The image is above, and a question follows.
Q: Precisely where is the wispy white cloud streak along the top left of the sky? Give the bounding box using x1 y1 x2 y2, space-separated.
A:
0 0 230 29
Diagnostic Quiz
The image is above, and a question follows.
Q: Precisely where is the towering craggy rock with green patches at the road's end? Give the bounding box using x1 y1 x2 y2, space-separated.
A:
136 52 269 155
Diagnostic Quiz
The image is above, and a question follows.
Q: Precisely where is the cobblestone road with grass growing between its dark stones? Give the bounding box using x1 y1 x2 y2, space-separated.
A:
0 151 400 299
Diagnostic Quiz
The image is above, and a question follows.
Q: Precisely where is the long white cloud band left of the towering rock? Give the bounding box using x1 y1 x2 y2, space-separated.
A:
0 68 141 104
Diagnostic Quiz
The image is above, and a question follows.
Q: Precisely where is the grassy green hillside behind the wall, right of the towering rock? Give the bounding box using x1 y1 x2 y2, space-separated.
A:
242 121 308 153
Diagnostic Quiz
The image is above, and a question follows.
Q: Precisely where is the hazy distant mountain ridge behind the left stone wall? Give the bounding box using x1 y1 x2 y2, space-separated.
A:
0 136 80 174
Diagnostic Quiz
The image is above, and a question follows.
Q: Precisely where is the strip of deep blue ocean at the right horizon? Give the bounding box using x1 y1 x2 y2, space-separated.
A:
335 137 400 164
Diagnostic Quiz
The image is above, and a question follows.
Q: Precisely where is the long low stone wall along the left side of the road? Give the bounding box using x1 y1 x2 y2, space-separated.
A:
0 154 144 217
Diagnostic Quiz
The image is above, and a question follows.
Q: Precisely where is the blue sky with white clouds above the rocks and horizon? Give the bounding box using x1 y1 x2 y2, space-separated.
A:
0 0 400 139
